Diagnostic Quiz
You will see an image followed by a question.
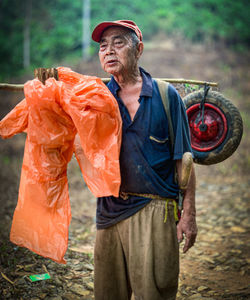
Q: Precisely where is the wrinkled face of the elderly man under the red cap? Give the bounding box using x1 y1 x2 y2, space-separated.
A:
99 27 139 76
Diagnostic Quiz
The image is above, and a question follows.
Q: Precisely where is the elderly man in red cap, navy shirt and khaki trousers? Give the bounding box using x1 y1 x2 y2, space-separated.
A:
92 20 197 300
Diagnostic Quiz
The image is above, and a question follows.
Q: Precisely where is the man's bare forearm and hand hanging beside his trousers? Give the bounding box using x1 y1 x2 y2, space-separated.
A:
177 160 197 253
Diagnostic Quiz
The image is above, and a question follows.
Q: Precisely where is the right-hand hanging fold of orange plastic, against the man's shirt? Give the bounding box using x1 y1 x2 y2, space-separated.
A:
58 68 122 197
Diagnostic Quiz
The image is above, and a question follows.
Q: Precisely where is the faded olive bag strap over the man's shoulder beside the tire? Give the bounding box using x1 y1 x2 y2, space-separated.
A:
155 79 174 154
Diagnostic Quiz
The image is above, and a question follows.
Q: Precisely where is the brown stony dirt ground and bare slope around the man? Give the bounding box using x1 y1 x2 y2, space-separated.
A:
0 37 250 300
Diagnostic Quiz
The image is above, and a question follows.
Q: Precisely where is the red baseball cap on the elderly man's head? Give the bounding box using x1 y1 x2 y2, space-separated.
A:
92 20 142 43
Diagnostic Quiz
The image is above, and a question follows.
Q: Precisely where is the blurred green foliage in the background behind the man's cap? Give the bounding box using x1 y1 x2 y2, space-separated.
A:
0 0 250 80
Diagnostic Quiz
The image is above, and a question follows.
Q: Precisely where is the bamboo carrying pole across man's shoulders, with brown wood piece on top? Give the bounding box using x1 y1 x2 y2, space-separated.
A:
0 68 218 92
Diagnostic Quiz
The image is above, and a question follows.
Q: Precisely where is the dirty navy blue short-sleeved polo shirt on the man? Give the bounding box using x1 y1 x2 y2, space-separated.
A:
96 68 192 229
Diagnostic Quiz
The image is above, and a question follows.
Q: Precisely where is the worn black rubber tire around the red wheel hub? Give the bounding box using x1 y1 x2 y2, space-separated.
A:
183 90 243 165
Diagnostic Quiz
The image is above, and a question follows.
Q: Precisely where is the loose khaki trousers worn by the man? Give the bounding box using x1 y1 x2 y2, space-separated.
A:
94 200 179 300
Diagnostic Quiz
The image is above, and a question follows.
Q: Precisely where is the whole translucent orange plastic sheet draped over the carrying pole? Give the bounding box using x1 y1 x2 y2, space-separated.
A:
0 68 121 263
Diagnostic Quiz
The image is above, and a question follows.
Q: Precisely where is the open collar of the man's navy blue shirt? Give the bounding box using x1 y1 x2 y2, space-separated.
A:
108 67 153 97
